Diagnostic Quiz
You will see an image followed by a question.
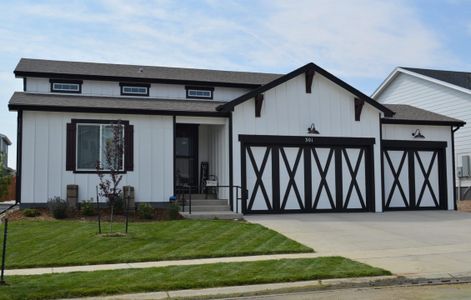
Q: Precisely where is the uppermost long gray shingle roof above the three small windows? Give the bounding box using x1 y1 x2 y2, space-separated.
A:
15 58 282 85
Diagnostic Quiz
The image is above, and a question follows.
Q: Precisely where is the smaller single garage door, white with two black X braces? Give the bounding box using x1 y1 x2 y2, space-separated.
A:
382 140 447 210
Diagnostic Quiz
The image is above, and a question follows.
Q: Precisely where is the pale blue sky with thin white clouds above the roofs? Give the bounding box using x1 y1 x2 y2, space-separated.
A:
0 0 471 167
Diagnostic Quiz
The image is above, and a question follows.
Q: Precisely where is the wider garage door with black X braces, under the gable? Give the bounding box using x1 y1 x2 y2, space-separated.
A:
239 135 374 214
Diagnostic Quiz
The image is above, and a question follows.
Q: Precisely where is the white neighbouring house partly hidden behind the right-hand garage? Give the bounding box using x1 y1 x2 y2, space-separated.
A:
372 67 471 199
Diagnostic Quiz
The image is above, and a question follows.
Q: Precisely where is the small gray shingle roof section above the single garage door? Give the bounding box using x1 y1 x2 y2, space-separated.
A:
384 104 465 125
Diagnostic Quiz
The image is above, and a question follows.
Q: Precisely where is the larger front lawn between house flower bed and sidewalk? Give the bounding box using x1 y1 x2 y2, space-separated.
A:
0 220 313 269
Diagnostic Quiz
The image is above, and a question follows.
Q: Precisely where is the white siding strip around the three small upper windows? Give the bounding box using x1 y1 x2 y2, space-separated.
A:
26 77 249 101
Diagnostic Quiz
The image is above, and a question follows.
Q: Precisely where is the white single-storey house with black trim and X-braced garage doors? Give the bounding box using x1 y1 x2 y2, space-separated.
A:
9 59 464 214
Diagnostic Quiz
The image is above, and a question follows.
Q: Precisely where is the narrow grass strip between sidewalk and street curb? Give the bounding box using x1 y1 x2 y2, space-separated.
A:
0 257 390 299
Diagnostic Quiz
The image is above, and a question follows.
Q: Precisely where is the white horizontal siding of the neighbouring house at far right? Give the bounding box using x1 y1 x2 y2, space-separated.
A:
375 73 471 186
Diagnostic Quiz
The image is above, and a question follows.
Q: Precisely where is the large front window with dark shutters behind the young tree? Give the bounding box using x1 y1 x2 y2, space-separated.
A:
66 119 133 173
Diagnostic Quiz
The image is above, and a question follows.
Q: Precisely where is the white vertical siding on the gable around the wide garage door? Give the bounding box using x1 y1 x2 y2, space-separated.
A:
232 73 382 212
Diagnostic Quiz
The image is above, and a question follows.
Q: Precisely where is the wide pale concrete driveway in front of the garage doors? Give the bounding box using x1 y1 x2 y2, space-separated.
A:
245 211 471 277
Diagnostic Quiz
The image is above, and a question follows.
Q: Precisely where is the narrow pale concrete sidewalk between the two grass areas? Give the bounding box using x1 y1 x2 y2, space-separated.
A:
5 253 324 276
